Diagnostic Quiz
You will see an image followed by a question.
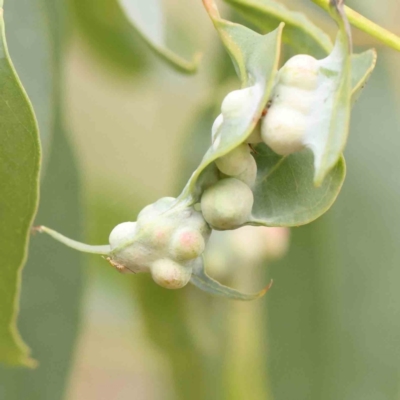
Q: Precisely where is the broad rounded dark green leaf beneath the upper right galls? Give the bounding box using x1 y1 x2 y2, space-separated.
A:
248 144 346 226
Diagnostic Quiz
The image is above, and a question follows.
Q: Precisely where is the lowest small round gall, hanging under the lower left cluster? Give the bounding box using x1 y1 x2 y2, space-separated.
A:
150 258 192 289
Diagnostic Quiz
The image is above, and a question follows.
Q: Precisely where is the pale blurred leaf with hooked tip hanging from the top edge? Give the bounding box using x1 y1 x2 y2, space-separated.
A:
118 0 201 74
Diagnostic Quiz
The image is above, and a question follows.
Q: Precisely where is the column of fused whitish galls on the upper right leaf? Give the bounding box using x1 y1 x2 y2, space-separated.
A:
261 54 320 155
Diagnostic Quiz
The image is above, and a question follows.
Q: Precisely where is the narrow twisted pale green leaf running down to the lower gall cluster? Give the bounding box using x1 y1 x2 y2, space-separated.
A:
180 0 283 202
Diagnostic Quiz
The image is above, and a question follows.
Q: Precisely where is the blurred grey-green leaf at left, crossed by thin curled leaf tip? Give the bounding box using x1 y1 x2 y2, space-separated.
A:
0 116 83 400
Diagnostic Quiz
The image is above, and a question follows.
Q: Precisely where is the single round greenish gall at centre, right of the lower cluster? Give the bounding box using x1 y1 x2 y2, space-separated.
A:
201 178 254 230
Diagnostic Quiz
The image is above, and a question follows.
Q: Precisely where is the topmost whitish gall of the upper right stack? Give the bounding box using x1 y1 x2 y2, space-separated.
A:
279 54 319 90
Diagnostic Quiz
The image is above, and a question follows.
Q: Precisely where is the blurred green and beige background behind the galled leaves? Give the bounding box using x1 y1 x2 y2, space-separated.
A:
0 0 400 400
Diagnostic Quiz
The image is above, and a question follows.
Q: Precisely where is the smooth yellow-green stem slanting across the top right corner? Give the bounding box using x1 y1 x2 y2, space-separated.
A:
311 0 400 51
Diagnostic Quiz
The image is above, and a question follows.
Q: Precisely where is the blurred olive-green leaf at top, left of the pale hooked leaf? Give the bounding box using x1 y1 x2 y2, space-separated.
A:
69 0 149 74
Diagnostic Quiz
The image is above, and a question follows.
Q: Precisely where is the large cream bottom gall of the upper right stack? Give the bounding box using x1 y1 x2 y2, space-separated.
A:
261 105 308 156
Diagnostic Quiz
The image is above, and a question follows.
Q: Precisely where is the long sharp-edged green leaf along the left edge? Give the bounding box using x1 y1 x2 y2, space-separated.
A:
0 3 40 366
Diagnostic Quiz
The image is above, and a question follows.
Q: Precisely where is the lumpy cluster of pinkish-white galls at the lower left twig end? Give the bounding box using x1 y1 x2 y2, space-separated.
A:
109 197 211 289
